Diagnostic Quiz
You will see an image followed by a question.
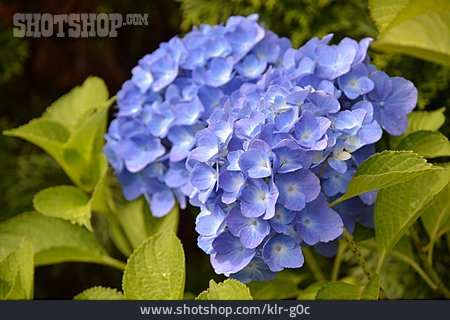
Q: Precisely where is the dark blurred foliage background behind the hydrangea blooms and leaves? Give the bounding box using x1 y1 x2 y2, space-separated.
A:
0 0 450 299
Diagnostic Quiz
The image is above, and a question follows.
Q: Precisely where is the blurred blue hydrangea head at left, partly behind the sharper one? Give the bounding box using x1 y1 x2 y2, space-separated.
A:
104 15 291 217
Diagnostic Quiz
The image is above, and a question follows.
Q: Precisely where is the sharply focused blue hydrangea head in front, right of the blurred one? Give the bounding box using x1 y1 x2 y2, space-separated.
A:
186 36 417 282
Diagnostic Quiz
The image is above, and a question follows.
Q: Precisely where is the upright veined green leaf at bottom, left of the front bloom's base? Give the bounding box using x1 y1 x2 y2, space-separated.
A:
122 233 185 300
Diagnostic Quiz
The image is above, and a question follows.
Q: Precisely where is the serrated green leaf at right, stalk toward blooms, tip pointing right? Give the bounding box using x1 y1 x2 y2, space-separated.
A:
330 151 434 206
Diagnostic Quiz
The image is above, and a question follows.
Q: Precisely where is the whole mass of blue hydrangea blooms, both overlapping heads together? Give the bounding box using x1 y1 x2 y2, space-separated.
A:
105 15 417 282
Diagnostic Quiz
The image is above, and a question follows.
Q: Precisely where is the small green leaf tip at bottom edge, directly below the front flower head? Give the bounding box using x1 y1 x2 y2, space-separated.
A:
196 279 252 300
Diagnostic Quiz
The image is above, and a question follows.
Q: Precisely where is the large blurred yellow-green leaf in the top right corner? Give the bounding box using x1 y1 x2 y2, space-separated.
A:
370 0 450 66
